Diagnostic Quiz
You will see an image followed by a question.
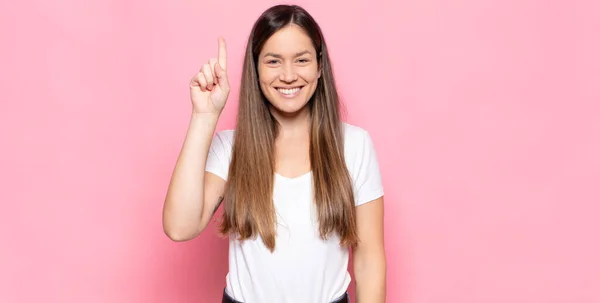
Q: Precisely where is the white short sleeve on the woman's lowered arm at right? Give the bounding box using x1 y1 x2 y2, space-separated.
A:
355 131 383 206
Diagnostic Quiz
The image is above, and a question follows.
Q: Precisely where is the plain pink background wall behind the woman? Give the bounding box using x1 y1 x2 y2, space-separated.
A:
0 0 600 303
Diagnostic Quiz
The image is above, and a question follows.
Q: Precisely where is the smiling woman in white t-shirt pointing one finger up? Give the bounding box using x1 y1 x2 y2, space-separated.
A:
163 5 385 303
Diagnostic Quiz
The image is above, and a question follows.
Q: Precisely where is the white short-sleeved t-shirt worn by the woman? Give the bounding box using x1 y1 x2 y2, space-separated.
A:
206 123 383 303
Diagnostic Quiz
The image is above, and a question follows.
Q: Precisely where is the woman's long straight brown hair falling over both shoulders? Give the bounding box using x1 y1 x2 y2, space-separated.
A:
220 5 358 251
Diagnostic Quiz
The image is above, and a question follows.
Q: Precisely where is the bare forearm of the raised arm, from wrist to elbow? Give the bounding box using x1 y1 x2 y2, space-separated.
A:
163 115 219 241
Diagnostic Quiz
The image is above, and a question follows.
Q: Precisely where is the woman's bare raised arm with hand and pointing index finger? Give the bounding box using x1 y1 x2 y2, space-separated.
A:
162 38 230 241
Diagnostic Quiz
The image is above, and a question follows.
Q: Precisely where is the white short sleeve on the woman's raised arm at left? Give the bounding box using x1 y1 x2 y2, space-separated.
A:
205 131 232 180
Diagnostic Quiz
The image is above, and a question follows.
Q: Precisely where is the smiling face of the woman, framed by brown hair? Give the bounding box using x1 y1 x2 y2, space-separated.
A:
257 24 321 115
